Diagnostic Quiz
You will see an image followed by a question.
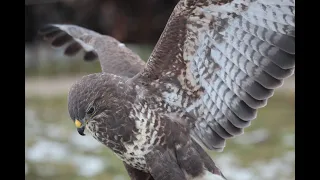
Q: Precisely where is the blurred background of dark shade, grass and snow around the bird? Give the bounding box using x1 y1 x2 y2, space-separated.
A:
25 0 295 180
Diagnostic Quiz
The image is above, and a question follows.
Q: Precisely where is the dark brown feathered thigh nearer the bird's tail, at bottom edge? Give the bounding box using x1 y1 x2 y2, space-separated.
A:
146 146 187 180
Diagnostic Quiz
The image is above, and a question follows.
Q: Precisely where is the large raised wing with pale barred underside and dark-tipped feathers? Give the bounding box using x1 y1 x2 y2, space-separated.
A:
133 0 295 150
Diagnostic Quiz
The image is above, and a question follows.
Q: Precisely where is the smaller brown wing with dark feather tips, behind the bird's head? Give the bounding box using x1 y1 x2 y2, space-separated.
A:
39 24 145 77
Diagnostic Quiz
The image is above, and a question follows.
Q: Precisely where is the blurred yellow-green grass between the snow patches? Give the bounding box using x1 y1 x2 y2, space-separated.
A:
26 90 295 180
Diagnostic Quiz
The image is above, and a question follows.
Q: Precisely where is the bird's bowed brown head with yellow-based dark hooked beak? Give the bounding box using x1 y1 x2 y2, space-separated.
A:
68 73 122 136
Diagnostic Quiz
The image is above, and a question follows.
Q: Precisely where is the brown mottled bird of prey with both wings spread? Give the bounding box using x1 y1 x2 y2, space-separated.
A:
39 0 295 180
